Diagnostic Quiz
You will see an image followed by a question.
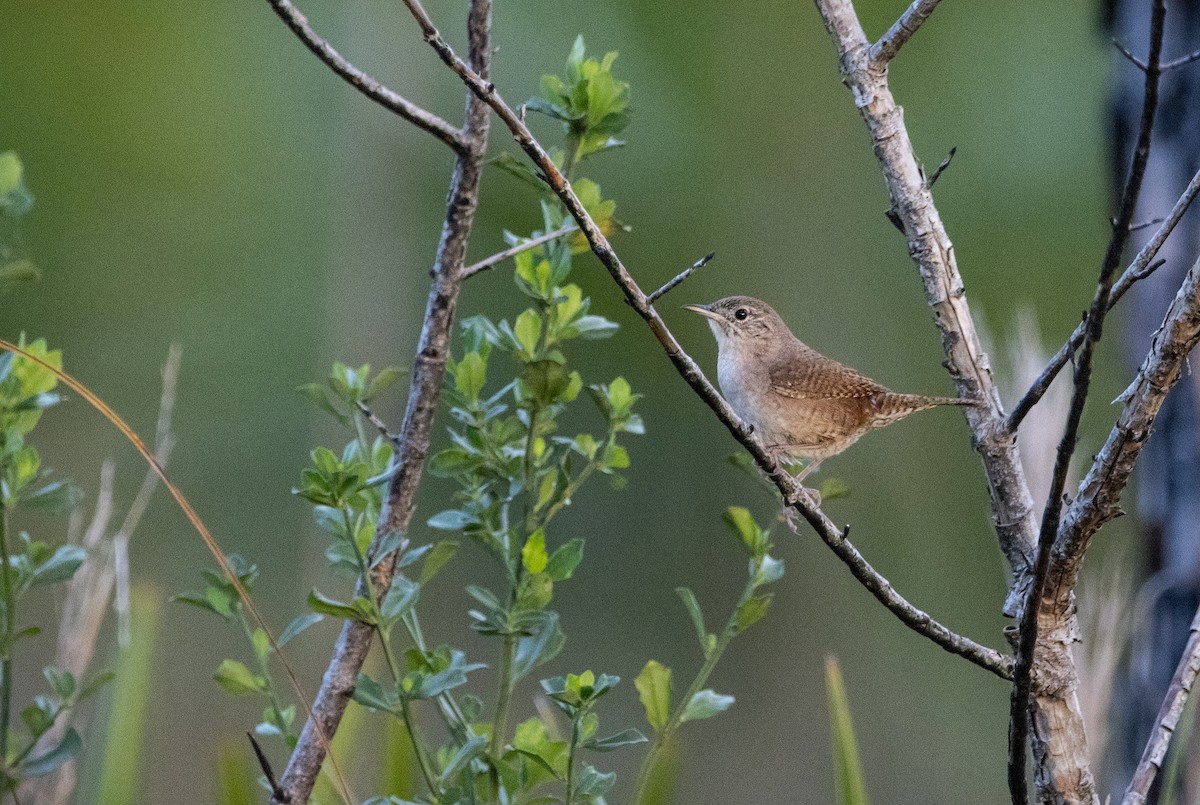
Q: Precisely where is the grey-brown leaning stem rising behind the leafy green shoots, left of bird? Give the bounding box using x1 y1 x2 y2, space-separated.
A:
271 0 492 805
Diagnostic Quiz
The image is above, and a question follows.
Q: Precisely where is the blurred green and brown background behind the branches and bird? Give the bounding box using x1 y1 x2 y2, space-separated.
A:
0 0 1121 805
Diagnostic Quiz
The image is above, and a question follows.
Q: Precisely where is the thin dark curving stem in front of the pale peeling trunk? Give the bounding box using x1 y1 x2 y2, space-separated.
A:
1008 0 1166 805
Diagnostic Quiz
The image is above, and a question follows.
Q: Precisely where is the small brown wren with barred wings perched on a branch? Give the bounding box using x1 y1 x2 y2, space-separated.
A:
684 296 978 481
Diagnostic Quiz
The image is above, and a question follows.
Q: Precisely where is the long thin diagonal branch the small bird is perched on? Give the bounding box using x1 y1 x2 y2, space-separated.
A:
404 0 1010 679
